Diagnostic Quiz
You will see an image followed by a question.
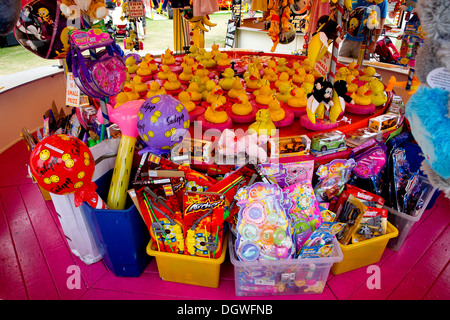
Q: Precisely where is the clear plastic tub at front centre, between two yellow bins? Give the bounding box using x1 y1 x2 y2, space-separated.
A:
228 237 343 296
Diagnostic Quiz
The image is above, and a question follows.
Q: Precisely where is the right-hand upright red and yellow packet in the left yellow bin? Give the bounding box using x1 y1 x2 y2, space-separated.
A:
183 192 225 259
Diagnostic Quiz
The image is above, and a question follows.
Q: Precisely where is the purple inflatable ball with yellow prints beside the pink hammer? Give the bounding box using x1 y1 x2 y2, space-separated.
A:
137 94 190 154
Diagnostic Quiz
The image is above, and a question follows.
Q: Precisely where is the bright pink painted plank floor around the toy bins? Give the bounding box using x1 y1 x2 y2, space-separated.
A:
0 141 450 300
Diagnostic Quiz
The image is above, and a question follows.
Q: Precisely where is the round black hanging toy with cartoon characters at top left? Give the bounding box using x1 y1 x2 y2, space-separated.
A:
14 0 75 59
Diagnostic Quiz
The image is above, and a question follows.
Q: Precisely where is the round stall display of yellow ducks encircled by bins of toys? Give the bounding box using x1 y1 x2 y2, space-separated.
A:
23 45 436 296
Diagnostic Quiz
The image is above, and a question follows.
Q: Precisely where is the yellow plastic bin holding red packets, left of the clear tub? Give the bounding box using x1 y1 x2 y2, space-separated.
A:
147 234 228 288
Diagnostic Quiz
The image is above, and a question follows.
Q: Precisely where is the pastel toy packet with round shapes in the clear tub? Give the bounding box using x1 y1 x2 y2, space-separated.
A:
235 182 295 261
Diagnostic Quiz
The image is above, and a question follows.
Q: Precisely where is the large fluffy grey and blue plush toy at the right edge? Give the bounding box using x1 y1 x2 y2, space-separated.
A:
405 0 450 198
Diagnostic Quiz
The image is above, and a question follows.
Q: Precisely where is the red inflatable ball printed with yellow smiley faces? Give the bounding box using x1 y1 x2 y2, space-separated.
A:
30 134 95 194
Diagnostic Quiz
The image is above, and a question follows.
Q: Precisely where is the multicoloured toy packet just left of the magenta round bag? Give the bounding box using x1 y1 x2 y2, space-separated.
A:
314 159 356 202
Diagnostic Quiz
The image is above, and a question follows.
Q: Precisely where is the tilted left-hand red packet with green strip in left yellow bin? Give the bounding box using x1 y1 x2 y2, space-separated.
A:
135 178 184 254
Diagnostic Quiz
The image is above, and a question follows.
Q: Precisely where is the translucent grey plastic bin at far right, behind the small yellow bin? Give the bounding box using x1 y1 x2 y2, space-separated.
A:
384 176 437 251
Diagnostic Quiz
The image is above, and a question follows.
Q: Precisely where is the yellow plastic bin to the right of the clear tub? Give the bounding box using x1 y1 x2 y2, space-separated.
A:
331 221 398 275
